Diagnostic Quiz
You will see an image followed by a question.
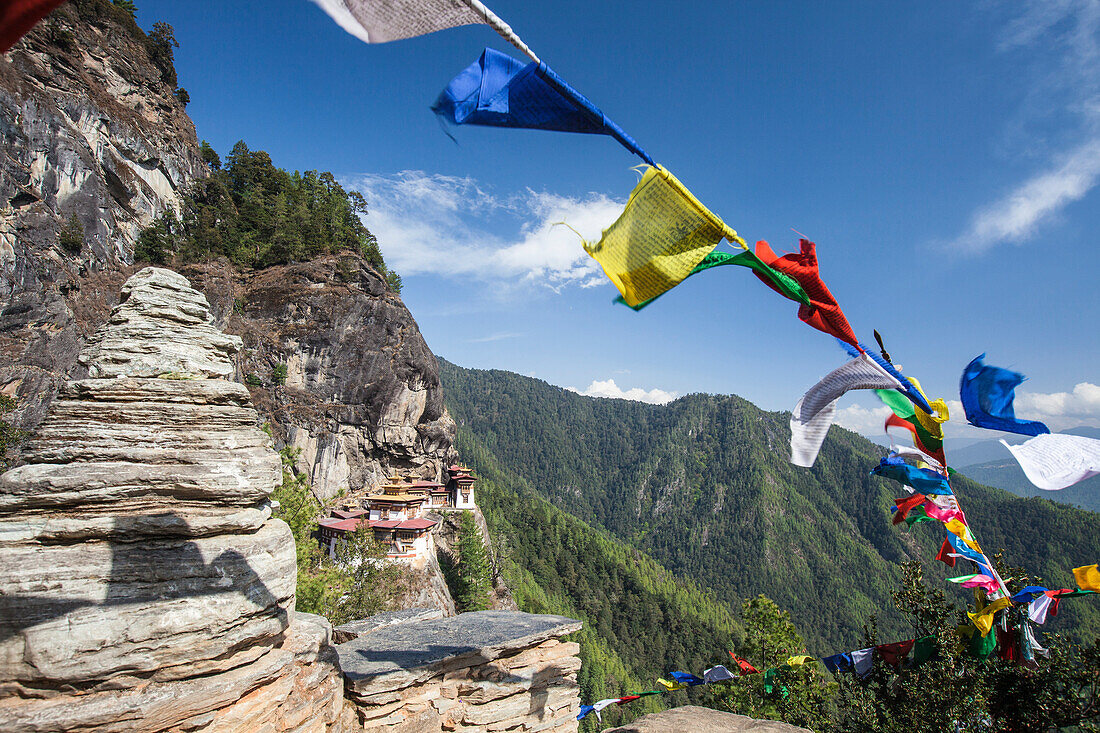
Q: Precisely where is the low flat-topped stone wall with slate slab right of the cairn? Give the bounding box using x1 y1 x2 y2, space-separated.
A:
337 611 581 733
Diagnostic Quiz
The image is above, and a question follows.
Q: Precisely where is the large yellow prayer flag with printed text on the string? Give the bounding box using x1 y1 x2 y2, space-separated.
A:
584 165 745 307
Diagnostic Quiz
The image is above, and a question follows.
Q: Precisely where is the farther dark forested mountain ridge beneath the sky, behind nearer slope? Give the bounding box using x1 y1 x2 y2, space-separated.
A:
440 360 1100 654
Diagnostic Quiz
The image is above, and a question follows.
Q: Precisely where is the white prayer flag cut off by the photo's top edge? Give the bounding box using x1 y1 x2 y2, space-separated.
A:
314 0 538 62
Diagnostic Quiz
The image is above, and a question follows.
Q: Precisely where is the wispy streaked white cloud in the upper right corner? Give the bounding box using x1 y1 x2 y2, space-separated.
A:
952 0 1100 253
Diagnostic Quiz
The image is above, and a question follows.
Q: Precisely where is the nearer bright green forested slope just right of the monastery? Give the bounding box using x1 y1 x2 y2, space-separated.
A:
455 430 744 730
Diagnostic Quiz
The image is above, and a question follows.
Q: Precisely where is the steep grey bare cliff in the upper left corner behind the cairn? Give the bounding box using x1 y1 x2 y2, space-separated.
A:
0 0 206 427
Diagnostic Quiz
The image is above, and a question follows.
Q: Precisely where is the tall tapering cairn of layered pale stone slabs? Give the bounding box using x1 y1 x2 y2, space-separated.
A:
0 269 344 731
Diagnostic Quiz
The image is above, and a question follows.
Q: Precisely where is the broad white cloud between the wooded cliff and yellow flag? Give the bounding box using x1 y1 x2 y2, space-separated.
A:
347 171 623 289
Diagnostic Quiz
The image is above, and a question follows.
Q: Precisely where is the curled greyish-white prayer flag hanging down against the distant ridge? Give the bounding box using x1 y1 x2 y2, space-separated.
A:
791 353 901 468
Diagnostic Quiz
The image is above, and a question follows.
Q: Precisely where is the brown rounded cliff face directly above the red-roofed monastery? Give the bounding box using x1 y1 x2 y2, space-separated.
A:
183 255 455 501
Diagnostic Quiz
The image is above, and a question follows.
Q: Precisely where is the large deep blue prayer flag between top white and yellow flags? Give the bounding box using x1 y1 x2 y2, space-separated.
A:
431 48 656 165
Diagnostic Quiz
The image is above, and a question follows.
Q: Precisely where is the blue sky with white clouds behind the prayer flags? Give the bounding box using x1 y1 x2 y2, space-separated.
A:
139 0 1100 437
